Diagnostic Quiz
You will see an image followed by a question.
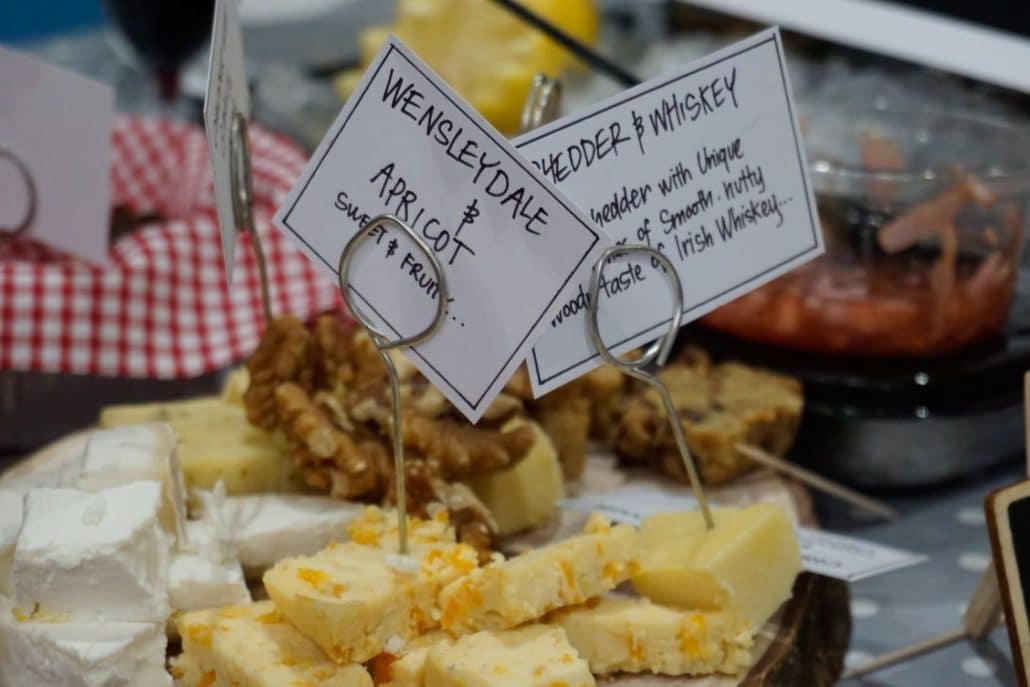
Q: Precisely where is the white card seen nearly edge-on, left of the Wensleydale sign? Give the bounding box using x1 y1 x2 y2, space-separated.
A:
204 0 250 283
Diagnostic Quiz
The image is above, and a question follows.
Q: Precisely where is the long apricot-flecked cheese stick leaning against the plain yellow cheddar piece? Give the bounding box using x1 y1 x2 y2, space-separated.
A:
440 516 637 632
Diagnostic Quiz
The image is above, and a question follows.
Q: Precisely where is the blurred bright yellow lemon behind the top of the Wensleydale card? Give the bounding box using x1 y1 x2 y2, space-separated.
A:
335 0 599 136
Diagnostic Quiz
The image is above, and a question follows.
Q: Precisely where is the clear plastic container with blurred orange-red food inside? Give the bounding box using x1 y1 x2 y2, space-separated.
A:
705 110 1030 356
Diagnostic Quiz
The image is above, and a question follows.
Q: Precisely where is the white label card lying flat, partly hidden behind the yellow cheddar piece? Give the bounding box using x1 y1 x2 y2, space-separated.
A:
561 486 927 582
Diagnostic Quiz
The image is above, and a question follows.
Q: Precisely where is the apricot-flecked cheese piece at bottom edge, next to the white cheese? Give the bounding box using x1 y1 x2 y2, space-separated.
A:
172 602 372 687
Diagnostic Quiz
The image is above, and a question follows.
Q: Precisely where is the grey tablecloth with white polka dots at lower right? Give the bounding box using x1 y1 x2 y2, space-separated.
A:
817 462 1026 687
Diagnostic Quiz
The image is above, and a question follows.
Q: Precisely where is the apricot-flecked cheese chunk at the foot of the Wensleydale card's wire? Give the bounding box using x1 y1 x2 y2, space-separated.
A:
265 543 478 663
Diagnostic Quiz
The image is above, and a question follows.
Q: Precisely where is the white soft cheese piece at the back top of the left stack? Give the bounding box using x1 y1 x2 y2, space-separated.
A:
78 422 186 544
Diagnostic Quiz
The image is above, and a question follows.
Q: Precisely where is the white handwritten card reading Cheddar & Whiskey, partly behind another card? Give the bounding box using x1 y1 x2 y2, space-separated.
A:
515 29 823 396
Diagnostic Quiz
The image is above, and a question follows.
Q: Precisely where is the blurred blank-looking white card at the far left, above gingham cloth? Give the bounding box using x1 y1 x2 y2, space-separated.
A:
0 46 114 265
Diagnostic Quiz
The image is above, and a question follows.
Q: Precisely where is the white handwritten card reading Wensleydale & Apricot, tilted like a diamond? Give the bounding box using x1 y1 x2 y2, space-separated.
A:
275 37 611 422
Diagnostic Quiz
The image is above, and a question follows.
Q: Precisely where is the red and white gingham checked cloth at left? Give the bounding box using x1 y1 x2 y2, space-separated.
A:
0 118 340 378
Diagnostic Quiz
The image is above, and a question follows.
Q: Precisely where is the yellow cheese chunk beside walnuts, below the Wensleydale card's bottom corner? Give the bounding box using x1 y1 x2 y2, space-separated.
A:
469 418 565 537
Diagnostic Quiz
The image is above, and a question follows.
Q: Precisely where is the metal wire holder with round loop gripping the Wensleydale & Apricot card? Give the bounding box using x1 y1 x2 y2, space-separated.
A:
337 214 447 554
